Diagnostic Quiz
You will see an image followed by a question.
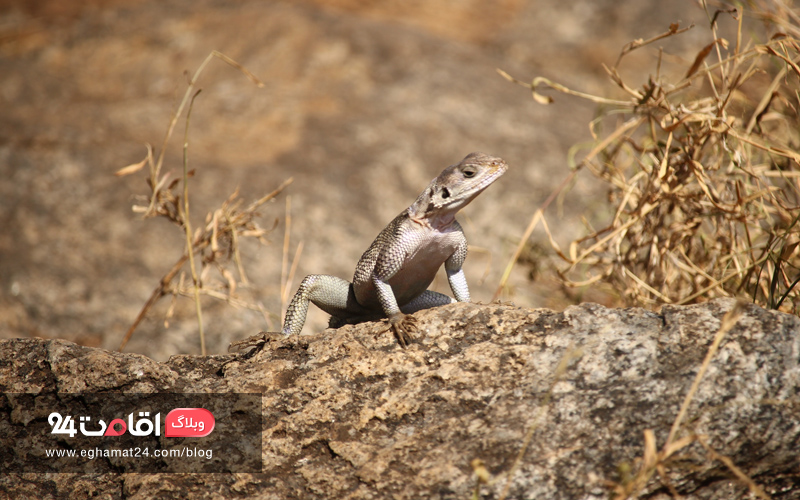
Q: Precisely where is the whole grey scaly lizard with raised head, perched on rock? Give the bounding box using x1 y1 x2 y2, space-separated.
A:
231 153 508 349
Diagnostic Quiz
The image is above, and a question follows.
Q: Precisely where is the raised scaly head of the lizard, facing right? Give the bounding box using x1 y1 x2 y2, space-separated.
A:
408 153 508 224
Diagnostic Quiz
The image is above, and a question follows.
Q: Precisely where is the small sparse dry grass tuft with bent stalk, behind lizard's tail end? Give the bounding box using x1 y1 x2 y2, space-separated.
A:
117 51 292 355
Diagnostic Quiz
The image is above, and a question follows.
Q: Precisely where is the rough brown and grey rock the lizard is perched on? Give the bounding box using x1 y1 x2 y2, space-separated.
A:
0 300 800 500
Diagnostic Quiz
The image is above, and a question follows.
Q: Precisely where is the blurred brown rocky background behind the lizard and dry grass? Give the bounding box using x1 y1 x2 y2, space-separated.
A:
0 0 735 360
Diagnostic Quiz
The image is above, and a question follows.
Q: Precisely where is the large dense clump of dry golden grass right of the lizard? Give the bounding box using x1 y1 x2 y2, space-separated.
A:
501 2 800 314
